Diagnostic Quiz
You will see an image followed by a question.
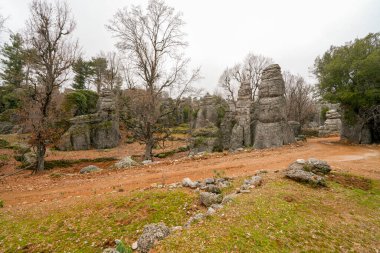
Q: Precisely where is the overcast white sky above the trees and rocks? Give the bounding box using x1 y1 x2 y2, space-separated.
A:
0 0 380 92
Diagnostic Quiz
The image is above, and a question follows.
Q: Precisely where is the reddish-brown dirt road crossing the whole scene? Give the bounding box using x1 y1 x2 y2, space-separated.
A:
0 137 380 209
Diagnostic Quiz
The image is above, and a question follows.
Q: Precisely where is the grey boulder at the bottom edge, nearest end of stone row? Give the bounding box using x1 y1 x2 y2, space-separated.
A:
137 222 170 253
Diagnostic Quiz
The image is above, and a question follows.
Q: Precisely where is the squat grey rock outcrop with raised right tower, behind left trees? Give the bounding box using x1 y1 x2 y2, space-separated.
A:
57 89 120 150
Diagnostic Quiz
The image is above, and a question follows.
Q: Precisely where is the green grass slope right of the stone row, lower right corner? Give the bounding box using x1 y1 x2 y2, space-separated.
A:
157 179 380 252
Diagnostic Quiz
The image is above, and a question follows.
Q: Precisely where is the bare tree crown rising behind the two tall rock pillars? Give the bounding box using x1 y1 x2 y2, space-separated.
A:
219 53 273 105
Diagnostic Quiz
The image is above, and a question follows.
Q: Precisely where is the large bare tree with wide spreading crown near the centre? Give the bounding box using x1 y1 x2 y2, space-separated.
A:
107 0 199 160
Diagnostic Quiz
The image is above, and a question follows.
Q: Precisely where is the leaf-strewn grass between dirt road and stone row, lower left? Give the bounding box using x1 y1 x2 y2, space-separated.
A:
0 190 197 252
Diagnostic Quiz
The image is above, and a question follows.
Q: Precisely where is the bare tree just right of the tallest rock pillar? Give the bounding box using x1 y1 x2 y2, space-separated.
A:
283 71 316 126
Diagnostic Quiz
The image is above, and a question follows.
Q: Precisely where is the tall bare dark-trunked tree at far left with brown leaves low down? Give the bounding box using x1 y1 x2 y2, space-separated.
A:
26 0 78 171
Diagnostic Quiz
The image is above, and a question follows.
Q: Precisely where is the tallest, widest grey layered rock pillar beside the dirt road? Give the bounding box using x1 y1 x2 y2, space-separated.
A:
254 64 295 148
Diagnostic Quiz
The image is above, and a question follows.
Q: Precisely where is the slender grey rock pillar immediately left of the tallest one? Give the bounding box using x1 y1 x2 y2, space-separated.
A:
230 81 253 150
